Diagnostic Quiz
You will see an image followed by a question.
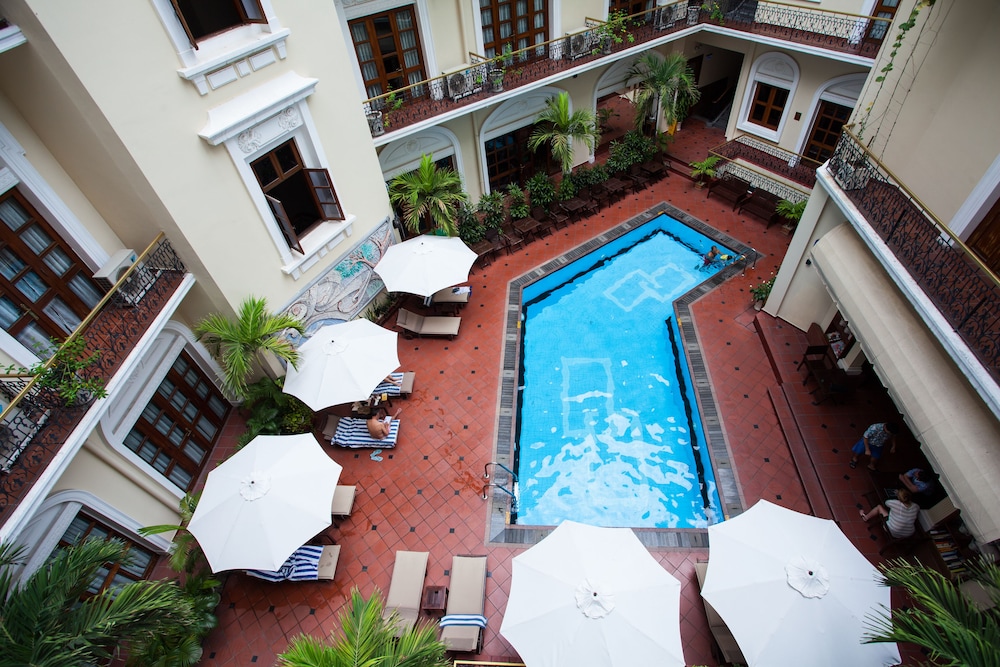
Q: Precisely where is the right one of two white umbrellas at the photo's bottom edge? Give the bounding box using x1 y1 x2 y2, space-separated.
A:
701 500 899 667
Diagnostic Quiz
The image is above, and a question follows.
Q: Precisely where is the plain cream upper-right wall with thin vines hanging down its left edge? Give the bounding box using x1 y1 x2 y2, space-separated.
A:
866 0 1000 221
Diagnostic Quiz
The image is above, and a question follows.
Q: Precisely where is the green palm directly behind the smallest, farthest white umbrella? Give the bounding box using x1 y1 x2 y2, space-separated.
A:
389 155 469 236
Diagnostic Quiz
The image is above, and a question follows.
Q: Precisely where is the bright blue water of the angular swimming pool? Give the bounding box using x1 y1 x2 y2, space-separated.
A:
517 215 733 528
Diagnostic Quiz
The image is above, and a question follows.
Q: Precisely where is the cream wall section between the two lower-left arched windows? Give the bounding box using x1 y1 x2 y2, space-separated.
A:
50 435 180 526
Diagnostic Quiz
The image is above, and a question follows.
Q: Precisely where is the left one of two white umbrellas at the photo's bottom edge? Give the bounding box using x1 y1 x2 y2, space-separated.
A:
500 521 686 667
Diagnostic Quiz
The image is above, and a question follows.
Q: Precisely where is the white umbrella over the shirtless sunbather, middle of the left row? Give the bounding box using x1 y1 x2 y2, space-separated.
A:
284 319 399 410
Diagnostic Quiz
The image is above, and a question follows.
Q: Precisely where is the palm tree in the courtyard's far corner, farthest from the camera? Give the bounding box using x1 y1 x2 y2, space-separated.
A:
625 53 701 134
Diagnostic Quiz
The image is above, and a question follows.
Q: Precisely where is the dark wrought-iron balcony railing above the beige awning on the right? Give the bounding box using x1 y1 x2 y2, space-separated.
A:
829 128 1000 381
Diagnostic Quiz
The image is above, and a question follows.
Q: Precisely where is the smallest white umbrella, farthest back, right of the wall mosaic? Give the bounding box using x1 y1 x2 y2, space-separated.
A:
375 234 476 296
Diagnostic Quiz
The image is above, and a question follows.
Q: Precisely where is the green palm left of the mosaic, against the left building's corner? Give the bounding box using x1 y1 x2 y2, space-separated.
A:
194 296 305 399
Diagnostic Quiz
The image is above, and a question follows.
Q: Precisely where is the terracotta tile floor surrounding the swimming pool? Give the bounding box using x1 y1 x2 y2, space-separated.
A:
195 121 920 667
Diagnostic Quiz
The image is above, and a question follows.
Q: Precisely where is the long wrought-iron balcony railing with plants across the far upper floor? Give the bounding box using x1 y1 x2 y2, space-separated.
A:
362 0 891 137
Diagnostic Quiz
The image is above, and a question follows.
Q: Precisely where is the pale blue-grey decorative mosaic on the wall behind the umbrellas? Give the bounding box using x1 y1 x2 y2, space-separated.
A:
284 218 393 340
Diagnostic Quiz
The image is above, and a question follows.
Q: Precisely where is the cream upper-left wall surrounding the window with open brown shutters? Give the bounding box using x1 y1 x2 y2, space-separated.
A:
0 0 390 318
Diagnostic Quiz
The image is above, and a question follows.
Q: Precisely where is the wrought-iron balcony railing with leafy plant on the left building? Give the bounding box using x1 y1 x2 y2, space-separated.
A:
0 233 185 523
